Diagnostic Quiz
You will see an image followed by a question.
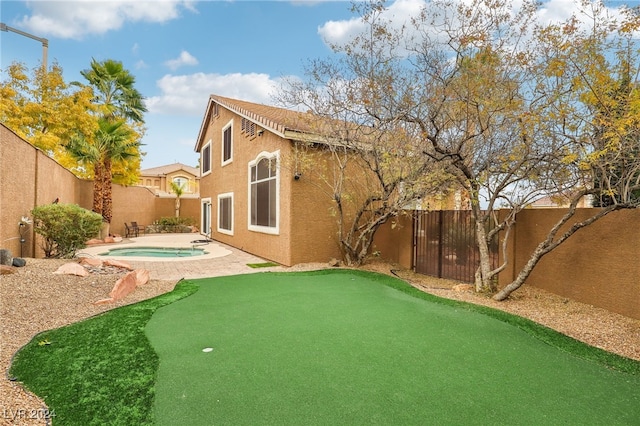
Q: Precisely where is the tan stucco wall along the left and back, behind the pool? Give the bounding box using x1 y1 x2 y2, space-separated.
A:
0 124 200 257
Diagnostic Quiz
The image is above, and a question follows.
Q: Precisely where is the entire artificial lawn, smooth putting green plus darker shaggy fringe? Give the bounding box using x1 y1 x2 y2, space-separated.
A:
10 270 640 425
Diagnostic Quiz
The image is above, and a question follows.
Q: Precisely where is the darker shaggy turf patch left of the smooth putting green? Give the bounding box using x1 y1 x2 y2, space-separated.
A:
9 283 198 425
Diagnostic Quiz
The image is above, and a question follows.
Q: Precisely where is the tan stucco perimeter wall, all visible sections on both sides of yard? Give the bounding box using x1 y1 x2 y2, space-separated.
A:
0 124 640 319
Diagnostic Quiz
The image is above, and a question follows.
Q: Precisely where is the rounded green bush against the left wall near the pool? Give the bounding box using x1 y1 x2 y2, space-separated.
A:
31 204 102 258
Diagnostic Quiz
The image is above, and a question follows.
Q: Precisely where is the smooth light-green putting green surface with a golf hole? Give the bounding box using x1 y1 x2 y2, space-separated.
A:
145 270 640 425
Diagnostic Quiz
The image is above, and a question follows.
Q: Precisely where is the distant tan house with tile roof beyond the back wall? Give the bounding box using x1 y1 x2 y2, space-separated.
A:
138 163 200 197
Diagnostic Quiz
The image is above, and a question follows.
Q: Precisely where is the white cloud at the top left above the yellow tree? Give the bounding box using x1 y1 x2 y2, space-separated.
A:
19 0 195 39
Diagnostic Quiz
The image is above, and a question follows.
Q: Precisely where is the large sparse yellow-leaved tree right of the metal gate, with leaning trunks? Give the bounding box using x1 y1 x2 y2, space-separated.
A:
286 0 640 300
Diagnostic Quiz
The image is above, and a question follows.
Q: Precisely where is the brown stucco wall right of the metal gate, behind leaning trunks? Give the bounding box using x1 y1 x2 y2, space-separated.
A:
500 209 640 319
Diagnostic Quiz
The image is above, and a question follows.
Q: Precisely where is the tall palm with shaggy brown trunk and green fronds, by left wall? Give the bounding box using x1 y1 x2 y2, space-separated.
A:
80 59 147 223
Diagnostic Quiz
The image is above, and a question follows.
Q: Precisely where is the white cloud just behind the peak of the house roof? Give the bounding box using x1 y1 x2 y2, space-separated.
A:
146 73 279 117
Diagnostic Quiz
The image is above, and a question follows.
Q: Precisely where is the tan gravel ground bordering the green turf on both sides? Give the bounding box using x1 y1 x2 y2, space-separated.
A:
0 259 640 425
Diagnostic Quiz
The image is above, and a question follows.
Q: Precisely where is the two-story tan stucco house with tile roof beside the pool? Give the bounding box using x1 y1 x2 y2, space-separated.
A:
195 95 465 266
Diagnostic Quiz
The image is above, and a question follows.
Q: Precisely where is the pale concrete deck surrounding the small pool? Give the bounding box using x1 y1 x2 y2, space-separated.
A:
77 234 286 281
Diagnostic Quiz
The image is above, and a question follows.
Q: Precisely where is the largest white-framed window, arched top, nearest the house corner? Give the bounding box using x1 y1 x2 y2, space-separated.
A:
249 152 280 234
